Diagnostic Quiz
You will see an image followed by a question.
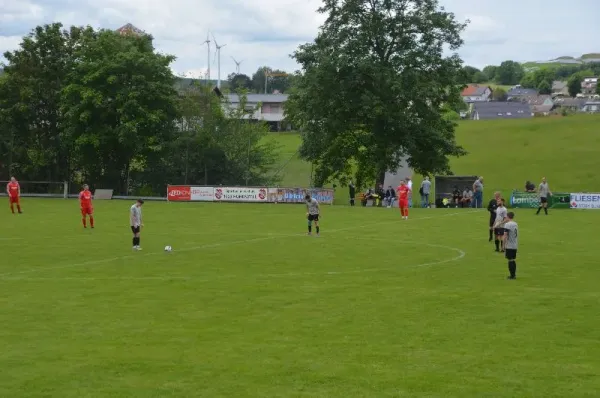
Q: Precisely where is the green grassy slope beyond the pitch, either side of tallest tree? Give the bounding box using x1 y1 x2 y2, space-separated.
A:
276 115 600 203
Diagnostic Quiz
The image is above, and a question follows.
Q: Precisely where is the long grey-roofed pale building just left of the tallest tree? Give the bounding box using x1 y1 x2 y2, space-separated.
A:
226 94 291 131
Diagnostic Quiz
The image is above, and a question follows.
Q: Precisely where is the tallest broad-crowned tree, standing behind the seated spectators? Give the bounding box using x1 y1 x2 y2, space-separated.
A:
286 0 466 186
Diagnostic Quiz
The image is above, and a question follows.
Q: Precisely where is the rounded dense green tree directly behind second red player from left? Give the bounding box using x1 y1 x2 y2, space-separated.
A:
61 31 177 194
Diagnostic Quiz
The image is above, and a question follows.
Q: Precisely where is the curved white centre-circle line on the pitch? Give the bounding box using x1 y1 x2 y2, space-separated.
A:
2 235 467 282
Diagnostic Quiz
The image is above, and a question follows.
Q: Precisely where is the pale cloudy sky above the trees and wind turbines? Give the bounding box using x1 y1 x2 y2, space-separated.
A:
0 0 600 78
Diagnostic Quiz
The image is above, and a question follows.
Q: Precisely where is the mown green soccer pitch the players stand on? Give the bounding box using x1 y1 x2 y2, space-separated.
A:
0 201 600 398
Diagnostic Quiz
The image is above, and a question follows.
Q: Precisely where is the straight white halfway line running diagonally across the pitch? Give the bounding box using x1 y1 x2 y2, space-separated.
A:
0 210 479 280
